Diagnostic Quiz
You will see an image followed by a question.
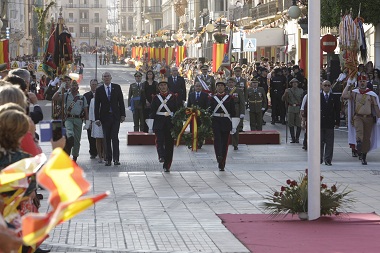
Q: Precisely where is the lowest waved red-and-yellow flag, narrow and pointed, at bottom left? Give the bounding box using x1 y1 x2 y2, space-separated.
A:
22 192 109 245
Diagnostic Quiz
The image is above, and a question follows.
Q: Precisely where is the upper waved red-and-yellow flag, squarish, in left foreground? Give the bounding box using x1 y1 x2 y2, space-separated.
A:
37 148 90 209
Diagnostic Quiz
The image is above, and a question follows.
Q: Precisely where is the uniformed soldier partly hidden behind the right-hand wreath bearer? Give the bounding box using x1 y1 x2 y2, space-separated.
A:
226 77 245 150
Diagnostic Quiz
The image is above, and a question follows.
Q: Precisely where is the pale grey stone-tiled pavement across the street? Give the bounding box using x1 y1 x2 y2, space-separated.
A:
36 122 380 252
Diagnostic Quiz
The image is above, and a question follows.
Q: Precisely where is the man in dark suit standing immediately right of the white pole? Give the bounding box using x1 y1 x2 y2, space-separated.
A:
321 80 340 166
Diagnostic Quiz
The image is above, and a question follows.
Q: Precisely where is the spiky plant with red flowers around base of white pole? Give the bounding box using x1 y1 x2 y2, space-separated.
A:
263 170 355 219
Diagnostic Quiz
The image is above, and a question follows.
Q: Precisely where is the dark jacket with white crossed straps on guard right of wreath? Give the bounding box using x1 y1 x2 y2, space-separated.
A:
210 93 235 131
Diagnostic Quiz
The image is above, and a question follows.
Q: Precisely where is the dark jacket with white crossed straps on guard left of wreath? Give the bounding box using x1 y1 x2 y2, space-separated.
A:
149 91 178 130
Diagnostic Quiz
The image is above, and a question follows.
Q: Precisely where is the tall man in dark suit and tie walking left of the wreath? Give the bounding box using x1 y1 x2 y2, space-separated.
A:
95 72 125 166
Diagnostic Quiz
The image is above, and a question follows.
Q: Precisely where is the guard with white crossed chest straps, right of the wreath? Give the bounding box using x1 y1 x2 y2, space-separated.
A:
210 80 235 171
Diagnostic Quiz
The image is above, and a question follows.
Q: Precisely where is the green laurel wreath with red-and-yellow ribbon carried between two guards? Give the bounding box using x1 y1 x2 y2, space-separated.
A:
171 106 213 146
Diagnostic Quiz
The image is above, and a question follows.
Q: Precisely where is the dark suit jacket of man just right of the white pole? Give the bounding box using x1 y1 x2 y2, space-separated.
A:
321 92 340 129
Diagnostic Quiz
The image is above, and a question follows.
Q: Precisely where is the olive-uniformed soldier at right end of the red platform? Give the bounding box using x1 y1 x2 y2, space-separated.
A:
247 79 268 131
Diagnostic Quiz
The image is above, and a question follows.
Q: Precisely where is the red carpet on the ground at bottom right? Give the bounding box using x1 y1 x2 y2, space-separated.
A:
218 213 380 253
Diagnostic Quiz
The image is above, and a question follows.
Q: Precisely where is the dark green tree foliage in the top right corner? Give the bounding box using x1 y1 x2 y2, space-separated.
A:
321 0 380 27
